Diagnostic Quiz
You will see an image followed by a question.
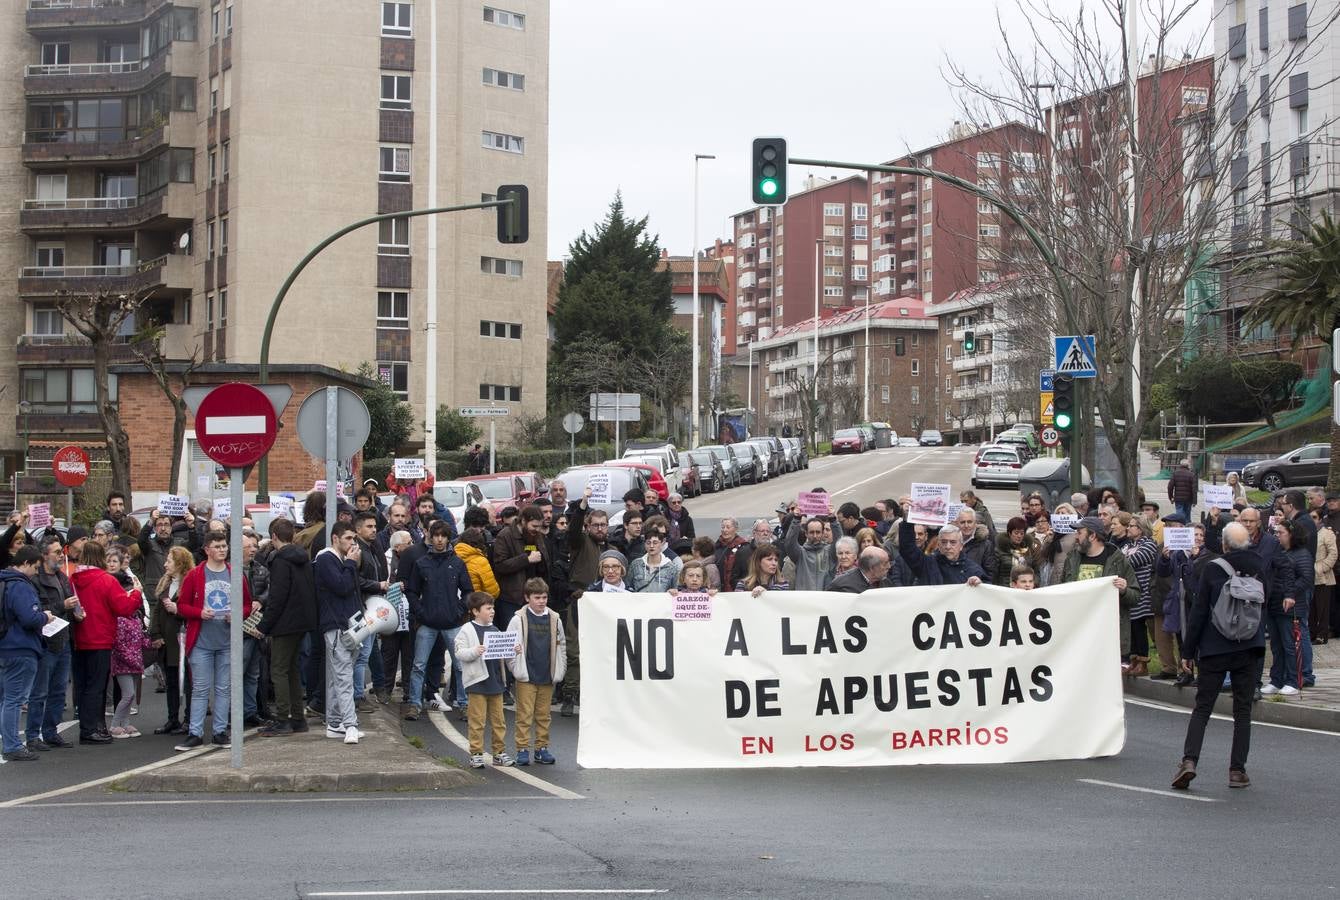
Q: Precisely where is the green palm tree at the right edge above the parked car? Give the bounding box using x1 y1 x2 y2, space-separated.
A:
1242 212 1340 490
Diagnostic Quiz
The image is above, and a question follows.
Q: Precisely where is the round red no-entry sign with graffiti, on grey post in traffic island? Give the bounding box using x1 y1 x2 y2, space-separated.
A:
182 382 293 769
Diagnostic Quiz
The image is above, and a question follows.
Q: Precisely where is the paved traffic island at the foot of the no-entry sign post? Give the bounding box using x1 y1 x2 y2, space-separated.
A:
115 706 478 793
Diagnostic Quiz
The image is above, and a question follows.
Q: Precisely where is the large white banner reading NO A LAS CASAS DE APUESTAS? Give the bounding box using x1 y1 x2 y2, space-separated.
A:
578 579 1126 769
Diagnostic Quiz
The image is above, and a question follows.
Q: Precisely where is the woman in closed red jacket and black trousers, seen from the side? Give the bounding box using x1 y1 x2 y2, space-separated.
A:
70 541 143 745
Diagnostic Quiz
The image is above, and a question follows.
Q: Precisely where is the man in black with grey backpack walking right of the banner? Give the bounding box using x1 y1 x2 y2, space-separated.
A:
1173 522 1265 790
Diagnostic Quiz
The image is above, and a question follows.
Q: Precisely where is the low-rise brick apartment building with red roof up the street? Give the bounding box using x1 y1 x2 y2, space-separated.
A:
749 297 939 437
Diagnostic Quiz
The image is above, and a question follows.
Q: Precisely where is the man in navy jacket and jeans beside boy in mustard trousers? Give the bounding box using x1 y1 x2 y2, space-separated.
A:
405 518 474 721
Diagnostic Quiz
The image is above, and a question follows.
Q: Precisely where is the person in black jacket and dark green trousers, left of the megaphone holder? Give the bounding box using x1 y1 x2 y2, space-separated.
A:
257 518 319 737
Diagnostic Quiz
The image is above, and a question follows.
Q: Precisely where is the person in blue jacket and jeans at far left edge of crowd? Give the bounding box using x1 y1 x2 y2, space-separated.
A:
0 544 52 762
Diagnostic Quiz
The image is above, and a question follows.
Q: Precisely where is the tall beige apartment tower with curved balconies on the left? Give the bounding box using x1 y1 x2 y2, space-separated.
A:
0 0 548 486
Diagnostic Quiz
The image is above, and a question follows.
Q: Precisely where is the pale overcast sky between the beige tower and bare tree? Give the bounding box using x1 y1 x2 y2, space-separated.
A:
548 0 1211 260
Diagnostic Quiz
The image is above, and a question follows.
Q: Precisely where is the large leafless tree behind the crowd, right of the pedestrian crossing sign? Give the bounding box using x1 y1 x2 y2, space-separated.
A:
947 0 1337 493
